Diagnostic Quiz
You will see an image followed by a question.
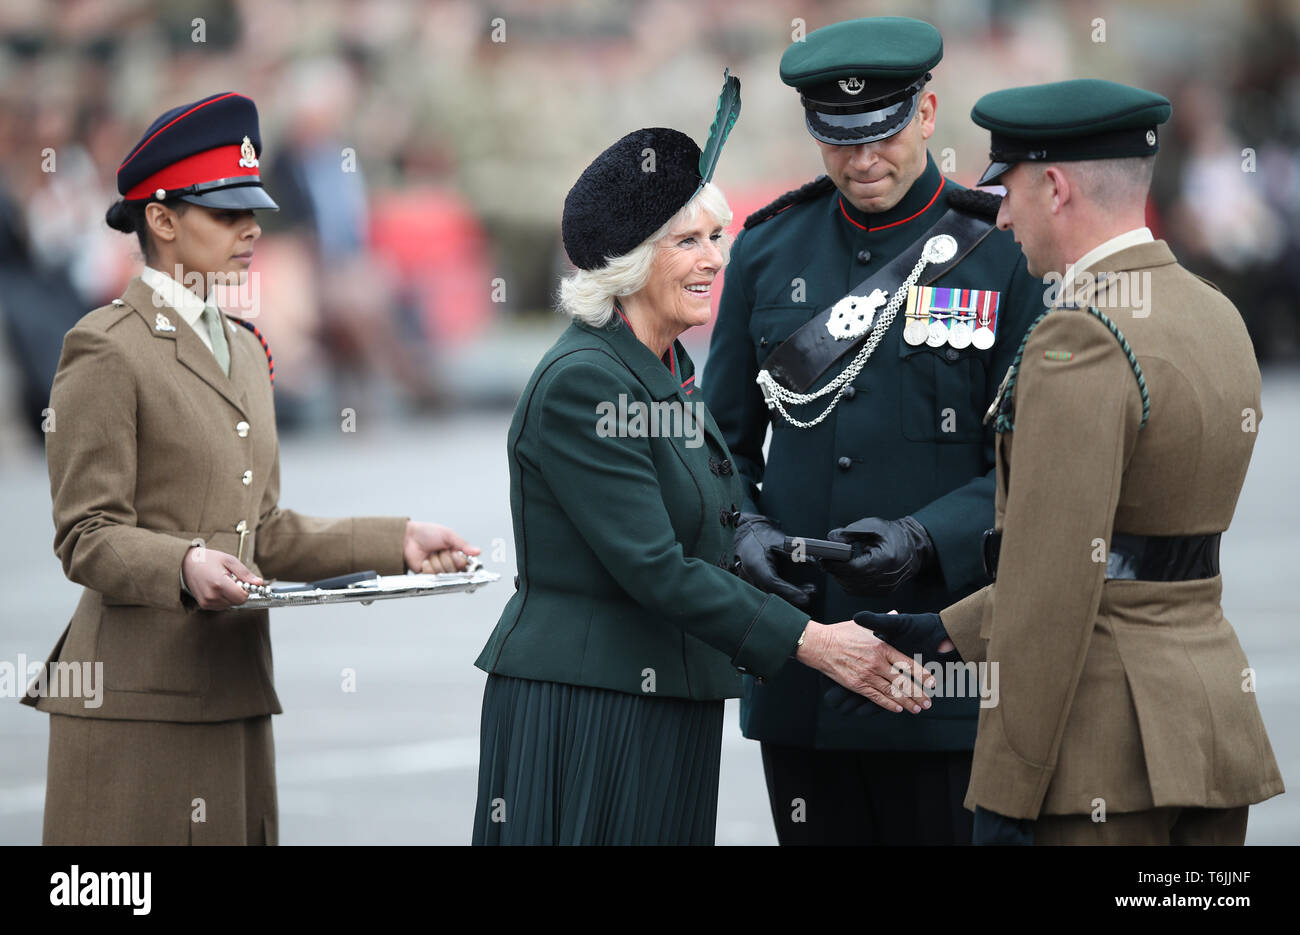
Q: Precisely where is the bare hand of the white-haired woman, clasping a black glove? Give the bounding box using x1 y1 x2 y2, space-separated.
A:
794 620 935 714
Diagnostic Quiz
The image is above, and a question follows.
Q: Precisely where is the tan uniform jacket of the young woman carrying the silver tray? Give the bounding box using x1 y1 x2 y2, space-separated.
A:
23 278 407 722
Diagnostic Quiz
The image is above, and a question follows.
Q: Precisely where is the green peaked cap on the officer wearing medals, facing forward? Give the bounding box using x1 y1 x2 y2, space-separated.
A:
781 16 944 146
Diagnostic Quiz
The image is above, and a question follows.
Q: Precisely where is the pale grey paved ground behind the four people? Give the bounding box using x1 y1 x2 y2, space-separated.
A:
0 373 1300 844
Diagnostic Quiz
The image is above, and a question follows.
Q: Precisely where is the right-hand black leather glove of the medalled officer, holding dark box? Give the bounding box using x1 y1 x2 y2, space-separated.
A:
822 516 935 594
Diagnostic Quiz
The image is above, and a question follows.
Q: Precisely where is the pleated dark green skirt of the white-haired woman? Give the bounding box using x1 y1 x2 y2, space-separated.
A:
473 675 723 844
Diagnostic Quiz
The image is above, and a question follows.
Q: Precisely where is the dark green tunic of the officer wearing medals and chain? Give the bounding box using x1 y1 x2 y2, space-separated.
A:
702 160 1044 750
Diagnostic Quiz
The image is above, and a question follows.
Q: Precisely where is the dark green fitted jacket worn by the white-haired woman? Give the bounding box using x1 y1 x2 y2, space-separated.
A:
476 316 809 700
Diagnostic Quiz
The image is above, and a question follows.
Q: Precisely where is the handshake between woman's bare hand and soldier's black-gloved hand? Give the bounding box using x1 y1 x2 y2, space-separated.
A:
794 611 957 714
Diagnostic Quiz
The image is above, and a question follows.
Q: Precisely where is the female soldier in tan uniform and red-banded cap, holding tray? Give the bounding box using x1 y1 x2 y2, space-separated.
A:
23 92 478 844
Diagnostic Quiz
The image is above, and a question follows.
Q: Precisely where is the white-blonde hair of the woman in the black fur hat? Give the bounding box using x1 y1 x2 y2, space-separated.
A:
556 182 732 328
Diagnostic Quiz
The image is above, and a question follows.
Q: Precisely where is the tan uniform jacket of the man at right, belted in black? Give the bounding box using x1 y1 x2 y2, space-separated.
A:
941 241 1283 818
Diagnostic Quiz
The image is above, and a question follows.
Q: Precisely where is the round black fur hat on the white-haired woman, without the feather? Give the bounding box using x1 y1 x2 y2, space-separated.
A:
560 126 703 269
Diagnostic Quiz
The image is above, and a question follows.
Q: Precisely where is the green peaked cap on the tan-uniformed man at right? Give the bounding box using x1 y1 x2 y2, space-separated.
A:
971 78 1173 185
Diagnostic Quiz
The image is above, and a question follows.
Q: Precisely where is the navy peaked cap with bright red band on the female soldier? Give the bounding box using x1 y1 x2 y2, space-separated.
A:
117 91 280 211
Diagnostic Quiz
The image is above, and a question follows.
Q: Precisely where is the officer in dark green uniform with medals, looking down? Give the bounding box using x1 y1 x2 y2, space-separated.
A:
702 17 1043 844
